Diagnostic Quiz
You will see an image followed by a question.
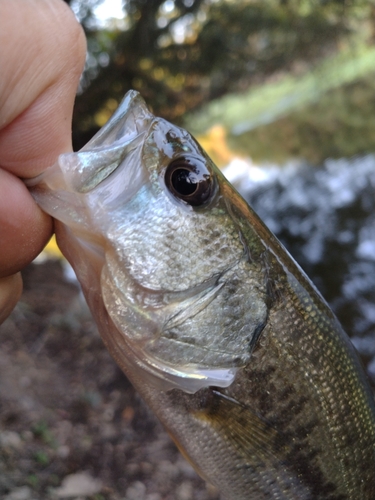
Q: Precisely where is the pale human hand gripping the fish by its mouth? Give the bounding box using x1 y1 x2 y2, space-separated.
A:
0 0 86 323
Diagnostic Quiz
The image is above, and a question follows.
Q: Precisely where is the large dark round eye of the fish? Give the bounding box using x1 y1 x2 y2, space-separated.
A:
164 156 215 207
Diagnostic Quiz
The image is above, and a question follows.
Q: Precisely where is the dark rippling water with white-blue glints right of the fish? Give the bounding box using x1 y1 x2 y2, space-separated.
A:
224 155 375 384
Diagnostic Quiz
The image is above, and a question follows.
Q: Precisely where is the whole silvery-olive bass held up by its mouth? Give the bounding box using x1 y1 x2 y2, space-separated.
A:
27 91 375 500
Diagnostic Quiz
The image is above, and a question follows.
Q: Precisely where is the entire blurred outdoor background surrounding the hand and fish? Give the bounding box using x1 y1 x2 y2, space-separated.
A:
0 0 375 500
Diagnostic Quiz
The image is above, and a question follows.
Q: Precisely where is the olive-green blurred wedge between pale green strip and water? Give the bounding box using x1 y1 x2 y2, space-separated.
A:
230 73 375 164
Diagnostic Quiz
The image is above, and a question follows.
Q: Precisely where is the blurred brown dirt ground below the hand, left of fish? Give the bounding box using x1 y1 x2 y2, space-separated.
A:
0 260 219 500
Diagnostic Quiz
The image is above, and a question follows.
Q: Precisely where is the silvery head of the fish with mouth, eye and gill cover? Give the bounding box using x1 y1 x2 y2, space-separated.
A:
31 91 268 393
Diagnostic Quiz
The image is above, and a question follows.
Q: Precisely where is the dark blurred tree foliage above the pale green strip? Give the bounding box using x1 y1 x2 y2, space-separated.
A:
71 0 371 147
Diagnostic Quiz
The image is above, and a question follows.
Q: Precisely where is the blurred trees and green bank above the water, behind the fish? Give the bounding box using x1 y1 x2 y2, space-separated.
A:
68 0 375 165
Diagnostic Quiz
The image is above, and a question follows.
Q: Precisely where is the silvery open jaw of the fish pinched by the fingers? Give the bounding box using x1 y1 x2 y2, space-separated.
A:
25 91 155 233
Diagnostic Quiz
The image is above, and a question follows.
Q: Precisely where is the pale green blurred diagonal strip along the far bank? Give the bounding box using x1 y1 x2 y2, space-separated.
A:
184 43 375 135
